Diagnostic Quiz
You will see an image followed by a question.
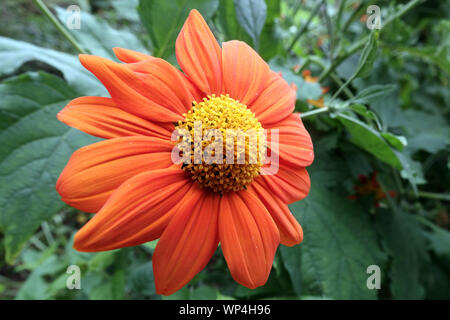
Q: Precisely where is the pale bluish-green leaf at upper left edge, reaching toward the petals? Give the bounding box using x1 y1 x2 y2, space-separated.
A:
0 37 106 95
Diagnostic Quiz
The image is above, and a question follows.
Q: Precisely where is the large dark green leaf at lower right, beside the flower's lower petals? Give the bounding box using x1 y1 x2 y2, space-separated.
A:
285 185 386 299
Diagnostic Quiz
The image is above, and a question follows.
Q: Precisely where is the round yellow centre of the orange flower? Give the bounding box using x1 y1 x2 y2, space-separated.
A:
176 95 266 194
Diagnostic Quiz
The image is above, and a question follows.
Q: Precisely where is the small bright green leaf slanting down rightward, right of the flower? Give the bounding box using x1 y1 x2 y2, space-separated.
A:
337 113 402 169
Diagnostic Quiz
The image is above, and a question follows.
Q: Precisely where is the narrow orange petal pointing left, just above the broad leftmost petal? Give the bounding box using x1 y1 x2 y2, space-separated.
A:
58 97 173 139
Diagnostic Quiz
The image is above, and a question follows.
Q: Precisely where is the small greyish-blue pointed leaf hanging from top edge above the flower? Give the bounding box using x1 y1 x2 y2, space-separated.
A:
233 0 267 51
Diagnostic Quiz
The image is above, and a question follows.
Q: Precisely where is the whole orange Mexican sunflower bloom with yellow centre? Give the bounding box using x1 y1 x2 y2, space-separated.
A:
56 10 314 295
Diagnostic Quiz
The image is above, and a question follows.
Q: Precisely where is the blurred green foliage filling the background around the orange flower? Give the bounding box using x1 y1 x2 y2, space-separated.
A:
0 0 450 299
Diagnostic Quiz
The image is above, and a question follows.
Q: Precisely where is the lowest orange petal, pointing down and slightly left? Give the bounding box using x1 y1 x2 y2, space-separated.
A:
152 189 220 295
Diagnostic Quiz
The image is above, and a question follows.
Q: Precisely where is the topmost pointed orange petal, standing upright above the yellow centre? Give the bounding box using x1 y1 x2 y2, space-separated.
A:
175 9 222 95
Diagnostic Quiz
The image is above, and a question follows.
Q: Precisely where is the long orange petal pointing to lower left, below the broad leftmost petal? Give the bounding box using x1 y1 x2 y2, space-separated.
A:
74 169 193 252
